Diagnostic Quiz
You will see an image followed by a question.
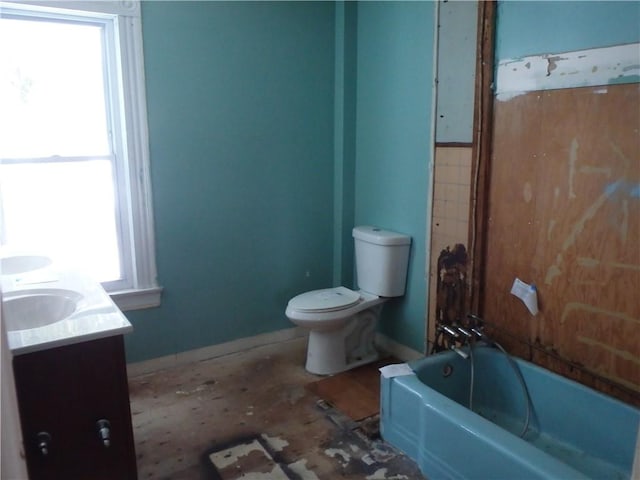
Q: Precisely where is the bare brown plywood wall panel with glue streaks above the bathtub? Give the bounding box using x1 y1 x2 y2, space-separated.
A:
482 84 640 403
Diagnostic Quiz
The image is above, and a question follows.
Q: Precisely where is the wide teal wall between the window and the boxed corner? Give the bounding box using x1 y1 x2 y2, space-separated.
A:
126 2 334 361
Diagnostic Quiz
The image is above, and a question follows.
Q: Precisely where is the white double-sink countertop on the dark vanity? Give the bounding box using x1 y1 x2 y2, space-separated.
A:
0 268 133 355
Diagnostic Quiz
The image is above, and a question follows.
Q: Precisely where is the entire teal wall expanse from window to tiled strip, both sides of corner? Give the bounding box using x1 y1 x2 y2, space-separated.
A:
126 1 435 362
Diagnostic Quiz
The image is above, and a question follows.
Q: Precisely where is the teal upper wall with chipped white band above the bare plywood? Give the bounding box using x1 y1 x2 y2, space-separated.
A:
495 1 640 97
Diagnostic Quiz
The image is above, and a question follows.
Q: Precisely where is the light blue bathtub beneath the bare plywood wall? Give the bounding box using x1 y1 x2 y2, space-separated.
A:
380 346 640 480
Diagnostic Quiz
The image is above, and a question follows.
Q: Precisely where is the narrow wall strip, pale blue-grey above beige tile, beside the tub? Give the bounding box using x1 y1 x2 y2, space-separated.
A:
426 0 478 351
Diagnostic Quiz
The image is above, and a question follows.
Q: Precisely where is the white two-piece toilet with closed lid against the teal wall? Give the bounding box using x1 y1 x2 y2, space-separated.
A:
285 226 411 375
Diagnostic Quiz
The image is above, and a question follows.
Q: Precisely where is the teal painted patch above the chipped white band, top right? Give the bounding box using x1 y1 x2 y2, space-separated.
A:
496 0 640 60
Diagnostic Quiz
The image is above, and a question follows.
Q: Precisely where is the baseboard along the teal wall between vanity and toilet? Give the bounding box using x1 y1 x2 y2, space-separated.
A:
127 327 308 378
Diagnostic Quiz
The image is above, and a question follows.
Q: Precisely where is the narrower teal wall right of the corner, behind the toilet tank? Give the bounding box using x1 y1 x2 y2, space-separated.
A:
355 2 436 351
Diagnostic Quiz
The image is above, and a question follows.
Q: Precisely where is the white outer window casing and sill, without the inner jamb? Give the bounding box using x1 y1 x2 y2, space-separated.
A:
0 0 162 310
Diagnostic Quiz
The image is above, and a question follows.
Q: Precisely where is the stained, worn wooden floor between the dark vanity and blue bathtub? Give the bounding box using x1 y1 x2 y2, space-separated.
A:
129 339 424 480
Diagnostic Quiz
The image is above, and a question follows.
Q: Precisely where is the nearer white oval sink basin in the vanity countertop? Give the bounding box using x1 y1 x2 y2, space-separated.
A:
2 288 82 331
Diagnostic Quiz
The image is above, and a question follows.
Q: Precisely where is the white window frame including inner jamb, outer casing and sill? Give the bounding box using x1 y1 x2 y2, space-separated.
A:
0 0 162 310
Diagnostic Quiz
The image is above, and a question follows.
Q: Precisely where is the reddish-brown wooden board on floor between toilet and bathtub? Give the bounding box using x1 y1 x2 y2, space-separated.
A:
306 358 398 421
